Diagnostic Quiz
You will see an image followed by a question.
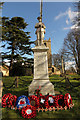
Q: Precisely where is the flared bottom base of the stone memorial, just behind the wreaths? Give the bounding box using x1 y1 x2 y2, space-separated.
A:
29 80 55 95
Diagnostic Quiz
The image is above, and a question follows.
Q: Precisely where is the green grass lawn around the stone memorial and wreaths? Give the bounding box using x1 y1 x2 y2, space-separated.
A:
2 75 80 120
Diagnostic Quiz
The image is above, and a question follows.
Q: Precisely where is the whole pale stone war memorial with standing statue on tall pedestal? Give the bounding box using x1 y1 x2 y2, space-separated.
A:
29 1 55 95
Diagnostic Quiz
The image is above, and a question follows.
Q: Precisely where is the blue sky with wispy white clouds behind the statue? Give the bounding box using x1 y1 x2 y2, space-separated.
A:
2 2 76 57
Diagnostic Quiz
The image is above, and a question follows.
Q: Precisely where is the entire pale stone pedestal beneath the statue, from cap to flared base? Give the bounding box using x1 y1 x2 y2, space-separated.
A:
29 46 55 95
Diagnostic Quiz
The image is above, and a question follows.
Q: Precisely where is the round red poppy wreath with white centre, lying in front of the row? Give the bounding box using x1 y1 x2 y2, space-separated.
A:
21 105 36 119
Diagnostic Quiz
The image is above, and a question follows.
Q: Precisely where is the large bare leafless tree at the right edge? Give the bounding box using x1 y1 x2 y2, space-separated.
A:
64 31 80 74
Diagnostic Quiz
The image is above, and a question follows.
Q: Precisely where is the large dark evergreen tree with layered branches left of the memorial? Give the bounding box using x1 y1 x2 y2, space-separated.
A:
2 17 33 75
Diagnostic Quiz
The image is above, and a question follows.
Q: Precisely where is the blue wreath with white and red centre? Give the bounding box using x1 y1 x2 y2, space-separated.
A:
16 95 30 109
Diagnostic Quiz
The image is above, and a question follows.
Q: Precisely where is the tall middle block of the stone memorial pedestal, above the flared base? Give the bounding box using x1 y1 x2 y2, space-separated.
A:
34 47 48 80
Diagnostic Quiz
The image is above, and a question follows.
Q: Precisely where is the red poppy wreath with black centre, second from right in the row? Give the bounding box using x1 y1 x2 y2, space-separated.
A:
55 95 64 107
